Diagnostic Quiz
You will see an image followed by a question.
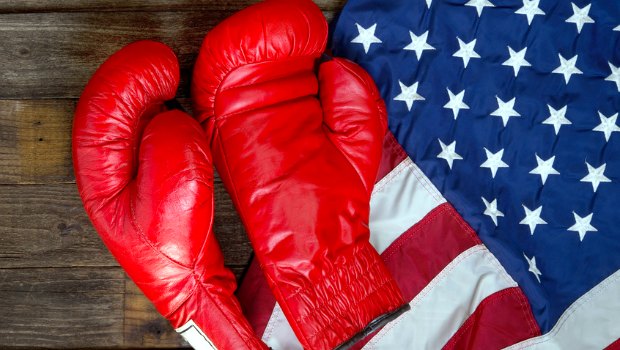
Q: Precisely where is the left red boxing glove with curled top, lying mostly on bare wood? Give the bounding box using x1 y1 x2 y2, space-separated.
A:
73 41 266 349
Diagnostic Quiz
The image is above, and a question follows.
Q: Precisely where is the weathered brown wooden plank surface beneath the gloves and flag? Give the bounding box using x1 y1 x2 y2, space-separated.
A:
0 0 345 348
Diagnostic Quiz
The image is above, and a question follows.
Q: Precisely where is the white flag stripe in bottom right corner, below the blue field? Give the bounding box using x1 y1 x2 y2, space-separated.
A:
508 270 620 349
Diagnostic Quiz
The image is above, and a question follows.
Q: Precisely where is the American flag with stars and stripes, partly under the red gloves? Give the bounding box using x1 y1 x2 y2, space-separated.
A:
240 0 620 349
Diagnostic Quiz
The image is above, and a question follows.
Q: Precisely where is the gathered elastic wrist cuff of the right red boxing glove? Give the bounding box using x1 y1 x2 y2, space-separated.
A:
281 242 406 349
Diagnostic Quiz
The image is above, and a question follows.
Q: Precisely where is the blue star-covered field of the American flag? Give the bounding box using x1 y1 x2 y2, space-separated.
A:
333 0 620 332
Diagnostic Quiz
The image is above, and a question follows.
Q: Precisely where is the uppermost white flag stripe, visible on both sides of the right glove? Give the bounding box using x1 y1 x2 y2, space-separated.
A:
263 157 446 350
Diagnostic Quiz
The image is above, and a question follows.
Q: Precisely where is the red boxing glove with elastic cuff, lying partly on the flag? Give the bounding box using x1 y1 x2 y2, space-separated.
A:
192 0 407 349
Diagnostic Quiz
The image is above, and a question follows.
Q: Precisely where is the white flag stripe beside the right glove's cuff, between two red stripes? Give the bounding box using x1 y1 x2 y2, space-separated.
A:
364 245 517 349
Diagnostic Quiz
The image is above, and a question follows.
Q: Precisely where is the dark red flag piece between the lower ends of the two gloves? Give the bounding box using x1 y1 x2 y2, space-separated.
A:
237 259 276 337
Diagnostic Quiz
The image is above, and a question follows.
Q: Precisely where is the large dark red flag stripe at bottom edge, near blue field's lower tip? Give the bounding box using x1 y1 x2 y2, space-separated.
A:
444 287 540 350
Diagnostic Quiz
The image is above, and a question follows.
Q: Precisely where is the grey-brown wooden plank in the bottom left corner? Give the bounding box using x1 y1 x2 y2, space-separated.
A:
0 268 125 349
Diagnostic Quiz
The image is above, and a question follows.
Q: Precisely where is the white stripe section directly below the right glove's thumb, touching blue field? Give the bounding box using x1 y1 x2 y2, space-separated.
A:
370 158 446 254
